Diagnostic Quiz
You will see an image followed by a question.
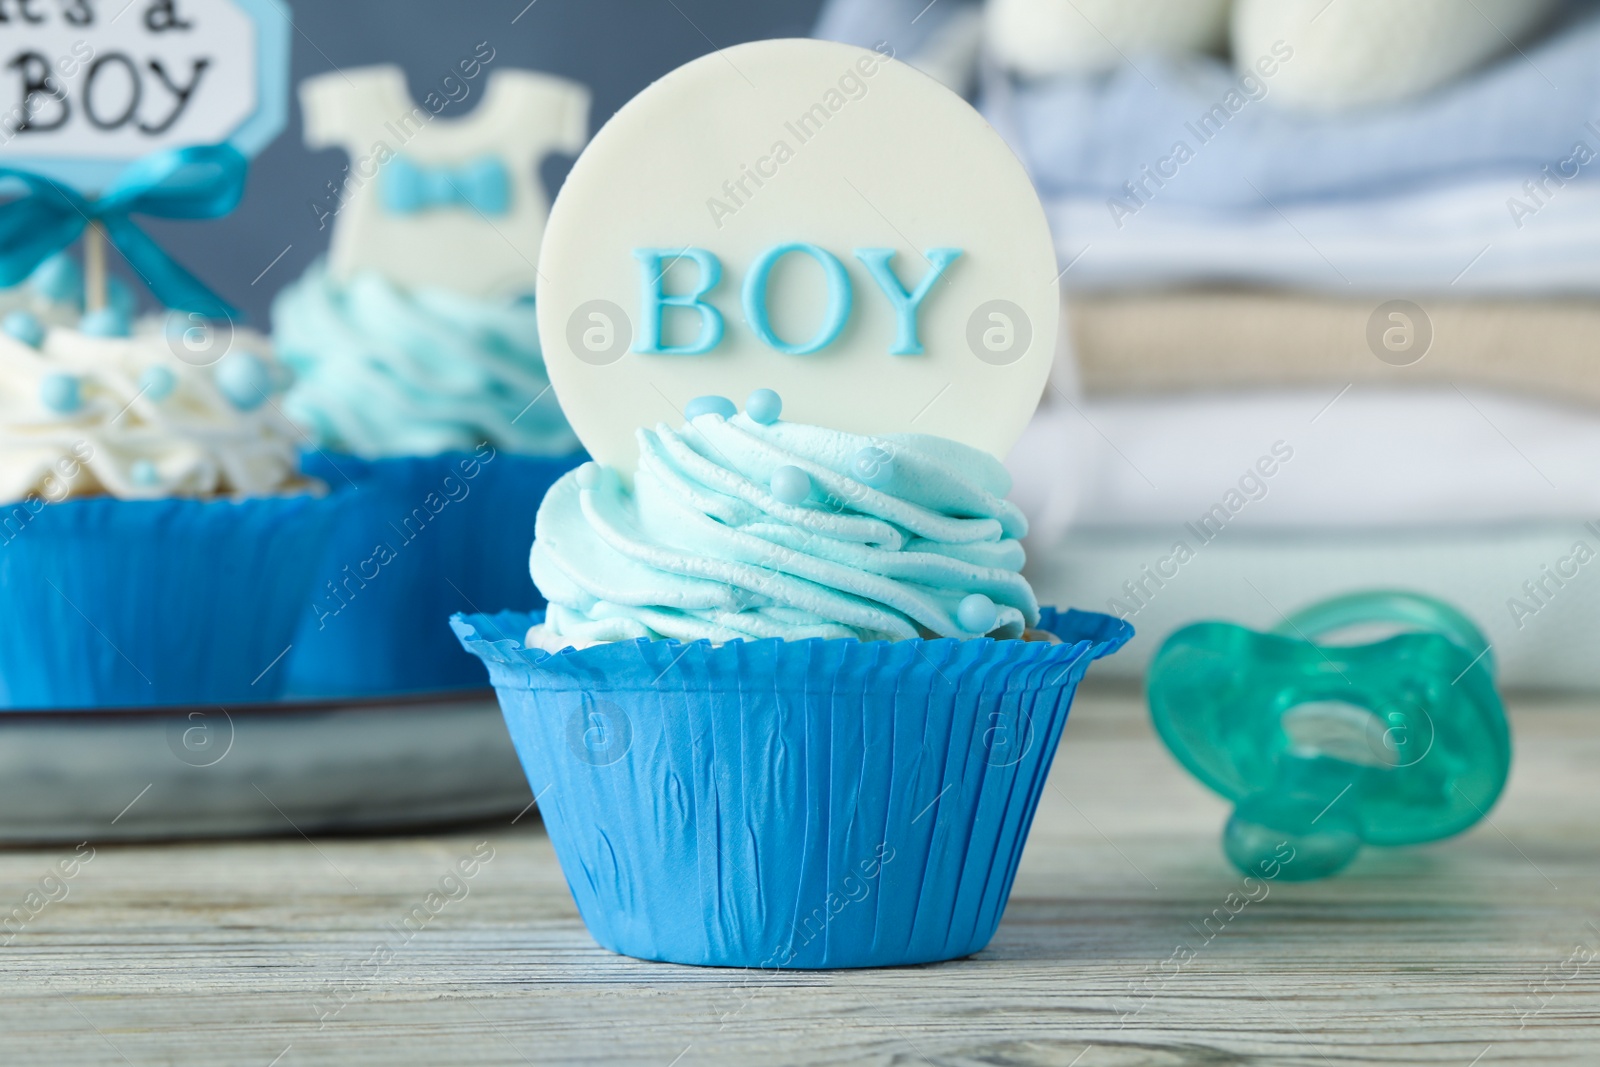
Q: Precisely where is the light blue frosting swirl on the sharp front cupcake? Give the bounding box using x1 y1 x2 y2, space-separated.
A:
530 413 1038 645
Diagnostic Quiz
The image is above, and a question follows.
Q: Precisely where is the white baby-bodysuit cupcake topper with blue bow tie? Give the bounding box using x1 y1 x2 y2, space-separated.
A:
301 63 589 298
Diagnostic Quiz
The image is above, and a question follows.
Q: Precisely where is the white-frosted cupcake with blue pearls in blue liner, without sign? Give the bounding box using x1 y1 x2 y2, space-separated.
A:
0 307 339 709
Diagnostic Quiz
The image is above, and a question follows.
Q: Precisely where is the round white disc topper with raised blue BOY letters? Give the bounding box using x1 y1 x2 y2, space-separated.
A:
538 40 1061 472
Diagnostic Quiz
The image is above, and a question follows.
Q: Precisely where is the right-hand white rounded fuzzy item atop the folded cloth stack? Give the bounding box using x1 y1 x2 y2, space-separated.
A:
1235 0 1558 112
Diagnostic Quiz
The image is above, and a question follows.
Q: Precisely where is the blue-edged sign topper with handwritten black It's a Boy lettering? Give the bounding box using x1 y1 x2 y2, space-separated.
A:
0 0 290 194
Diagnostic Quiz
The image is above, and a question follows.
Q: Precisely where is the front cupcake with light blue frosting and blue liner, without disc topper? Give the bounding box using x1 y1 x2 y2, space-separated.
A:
454 390 1131 968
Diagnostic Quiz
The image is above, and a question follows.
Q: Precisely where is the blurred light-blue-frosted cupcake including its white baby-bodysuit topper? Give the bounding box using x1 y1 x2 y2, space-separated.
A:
272 62 589 697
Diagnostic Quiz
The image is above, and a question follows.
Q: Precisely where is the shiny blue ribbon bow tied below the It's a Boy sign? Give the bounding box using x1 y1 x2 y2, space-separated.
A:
0 144 250 320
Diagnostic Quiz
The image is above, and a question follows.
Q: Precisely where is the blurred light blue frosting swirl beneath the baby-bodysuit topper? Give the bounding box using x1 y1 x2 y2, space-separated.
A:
272 262 578 459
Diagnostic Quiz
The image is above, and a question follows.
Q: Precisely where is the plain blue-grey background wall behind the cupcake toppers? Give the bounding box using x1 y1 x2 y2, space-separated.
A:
140 0 821 328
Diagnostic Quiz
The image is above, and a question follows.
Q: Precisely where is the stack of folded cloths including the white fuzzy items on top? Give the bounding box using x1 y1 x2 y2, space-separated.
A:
818 0 1600 688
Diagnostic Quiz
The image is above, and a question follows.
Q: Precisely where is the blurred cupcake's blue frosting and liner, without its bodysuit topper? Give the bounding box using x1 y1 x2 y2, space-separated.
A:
272 264 582 697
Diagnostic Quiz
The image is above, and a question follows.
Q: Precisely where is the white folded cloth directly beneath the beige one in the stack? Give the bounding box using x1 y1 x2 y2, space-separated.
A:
1006 387 1600 552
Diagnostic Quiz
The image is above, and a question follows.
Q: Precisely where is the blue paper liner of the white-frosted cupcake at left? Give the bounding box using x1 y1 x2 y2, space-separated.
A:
0 493 347 709
